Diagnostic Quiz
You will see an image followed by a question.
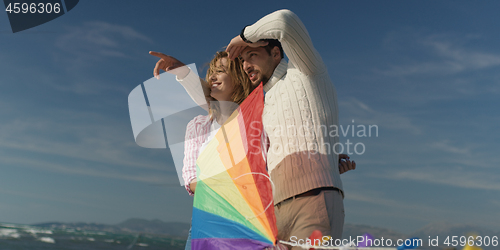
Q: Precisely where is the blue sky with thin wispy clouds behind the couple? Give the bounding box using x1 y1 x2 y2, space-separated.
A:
0 0 500 232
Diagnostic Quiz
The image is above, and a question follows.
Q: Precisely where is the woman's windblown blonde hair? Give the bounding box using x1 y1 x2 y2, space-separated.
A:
206 51 254 117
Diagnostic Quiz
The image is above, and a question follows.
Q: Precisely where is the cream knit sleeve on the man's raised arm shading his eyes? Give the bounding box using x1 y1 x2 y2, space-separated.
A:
243 10 326 75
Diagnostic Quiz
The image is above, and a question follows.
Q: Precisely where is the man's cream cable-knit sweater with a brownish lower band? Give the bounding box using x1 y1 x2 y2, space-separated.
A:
243 10 342 203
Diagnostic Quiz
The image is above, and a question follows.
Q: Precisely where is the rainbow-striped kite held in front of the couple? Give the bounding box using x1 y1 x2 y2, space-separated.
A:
191 85 278 249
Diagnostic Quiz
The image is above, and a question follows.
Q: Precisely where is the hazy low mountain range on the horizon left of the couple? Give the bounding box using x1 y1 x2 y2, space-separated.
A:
33 219 190 238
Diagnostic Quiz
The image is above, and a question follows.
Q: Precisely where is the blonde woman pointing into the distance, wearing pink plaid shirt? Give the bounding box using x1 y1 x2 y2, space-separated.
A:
150 51 255 249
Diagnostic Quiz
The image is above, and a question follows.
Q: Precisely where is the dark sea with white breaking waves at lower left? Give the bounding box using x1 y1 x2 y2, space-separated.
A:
0 223 186 250
